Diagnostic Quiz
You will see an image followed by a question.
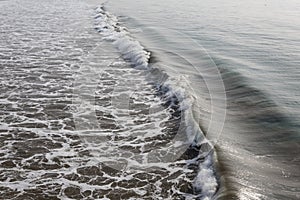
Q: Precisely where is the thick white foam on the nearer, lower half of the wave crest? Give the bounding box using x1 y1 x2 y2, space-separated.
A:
162 79 218 200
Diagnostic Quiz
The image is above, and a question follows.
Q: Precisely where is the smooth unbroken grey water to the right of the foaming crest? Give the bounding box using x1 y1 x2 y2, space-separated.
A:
103 0 300 199
